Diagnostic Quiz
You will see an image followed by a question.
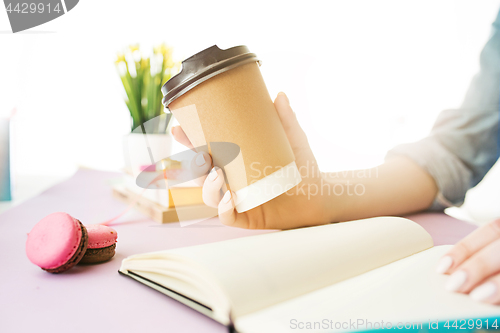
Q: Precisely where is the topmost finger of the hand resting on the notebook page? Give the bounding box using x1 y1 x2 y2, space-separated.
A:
436 220 500 273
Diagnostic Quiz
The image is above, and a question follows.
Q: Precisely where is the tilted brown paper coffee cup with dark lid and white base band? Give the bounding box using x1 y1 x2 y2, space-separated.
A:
162 46 301 212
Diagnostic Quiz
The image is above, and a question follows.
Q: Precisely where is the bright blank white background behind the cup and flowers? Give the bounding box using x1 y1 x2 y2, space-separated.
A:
0 0 500 180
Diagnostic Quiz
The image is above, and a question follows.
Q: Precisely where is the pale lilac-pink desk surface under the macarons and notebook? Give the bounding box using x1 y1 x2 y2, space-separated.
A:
0 169 475 333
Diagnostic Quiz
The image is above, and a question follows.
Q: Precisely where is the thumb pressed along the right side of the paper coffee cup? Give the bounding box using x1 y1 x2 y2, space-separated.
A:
274 92 311 153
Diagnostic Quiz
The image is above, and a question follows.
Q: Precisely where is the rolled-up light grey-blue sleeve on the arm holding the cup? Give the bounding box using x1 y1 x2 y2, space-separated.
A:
386 12 500 210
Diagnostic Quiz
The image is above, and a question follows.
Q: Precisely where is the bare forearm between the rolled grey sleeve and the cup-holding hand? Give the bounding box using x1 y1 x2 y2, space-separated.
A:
323 157 437 222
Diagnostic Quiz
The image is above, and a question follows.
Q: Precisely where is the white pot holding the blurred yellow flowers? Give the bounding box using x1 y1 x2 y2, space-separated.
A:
123 133 173 177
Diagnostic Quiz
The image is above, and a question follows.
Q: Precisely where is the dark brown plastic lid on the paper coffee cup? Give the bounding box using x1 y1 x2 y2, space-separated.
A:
161 45 260 107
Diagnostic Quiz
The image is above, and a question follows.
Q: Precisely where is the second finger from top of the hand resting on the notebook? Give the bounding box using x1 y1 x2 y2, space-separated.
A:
445 239 500 293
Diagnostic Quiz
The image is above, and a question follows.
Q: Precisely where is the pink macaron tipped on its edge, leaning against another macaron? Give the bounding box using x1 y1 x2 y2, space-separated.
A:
26 212 88 273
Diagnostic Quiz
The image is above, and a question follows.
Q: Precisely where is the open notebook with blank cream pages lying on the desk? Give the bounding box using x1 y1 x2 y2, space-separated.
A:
120 217 500 333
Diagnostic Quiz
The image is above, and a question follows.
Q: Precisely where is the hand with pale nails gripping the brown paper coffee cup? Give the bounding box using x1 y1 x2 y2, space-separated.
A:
172 93 332 229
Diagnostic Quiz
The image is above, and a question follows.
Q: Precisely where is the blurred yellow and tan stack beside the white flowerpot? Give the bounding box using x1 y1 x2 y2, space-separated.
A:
113 161 217 223
